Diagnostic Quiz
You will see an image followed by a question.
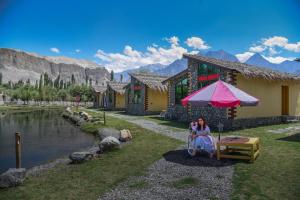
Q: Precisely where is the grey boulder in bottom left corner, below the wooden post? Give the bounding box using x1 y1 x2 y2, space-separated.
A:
0 168 26 188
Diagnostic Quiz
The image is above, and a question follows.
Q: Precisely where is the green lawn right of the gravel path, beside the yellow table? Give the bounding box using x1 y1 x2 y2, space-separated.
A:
220 124 300 200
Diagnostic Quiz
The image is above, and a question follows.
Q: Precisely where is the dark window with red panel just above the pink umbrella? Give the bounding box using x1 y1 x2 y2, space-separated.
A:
198 64 220 89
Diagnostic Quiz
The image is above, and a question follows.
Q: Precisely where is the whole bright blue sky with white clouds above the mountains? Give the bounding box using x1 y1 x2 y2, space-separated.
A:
0 0 300 71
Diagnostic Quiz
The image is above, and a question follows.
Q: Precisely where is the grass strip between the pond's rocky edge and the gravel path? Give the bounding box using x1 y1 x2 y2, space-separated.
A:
0 108 181 200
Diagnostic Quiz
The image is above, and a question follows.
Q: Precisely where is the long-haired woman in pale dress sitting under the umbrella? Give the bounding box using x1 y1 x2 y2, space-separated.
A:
192 117 215 158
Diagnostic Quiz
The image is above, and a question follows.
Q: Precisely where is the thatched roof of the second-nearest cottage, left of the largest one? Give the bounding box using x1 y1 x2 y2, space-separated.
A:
129 73 168 91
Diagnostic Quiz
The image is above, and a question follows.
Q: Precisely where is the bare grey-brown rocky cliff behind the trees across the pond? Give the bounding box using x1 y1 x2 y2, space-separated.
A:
0 48 110 84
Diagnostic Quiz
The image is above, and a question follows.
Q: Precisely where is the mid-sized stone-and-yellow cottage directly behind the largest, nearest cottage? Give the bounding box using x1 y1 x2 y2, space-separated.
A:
125 73 168 115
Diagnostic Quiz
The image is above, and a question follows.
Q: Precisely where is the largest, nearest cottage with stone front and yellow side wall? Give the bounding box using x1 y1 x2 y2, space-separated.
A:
163 54 300 129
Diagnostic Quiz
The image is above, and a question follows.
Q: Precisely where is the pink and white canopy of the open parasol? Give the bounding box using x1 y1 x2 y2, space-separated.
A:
181 80 259 108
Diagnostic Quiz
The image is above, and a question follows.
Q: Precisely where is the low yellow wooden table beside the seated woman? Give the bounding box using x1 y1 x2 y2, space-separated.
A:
217 137 260 162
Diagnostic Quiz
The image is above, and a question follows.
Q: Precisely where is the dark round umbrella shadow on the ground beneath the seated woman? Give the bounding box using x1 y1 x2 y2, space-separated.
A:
163 149 237 167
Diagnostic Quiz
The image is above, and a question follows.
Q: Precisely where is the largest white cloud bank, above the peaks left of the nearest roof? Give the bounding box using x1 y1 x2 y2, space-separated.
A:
95 36 203 72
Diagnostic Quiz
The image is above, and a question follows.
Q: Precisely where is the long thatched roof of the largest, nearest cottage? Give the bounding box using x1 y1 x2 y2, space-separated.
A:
183 54 300 81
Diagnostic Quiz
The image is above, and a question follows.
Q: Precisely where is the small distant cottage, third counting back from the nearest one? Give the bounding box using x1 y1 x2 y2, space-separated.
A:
106 82 128 110
